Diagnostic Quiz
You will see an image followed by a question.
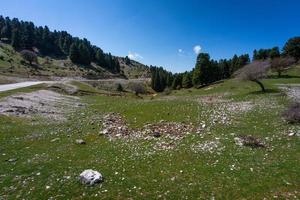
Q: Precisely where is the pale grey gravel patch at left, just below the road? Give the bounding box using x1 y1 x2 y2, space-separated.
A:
0 90 82 120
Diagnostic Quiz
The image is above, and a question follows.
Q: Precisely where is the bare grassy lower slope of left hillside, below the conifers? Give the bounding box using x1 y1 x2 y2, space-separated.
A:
0 42 150 80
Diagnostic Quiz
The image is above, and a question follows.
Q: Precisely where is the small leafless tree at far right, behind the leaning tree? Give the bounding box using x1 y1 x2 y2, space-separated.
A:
271 56 296 78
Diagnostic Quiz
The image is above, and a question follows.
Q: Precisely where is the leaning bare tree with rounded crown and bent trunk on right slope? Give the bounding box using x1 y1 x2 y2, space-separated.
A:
236 60 271 92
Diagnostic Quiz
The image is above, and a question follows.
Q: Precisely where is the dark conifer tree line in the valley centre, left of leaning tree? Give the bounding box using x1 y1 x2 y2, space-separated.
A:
150 53 250 92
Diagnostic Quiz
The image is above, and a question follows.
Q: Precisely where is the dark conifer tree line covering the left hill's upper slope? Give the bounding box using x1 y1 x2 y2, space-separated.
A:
0 16 120 73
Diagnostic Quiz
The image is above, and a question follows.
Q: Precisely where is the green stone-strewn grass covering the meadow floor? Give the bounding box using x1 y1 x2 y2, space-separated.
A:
0 69 300 199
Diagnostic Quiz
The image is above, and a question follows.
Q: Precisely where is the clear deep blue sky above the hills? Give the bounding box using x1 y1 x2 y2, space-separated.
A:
0 0 300 72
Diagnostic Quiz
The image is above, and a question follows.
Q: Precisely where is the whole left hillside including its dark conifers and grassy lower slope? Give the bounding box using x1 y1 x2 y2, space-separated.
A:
0 15 150 82
